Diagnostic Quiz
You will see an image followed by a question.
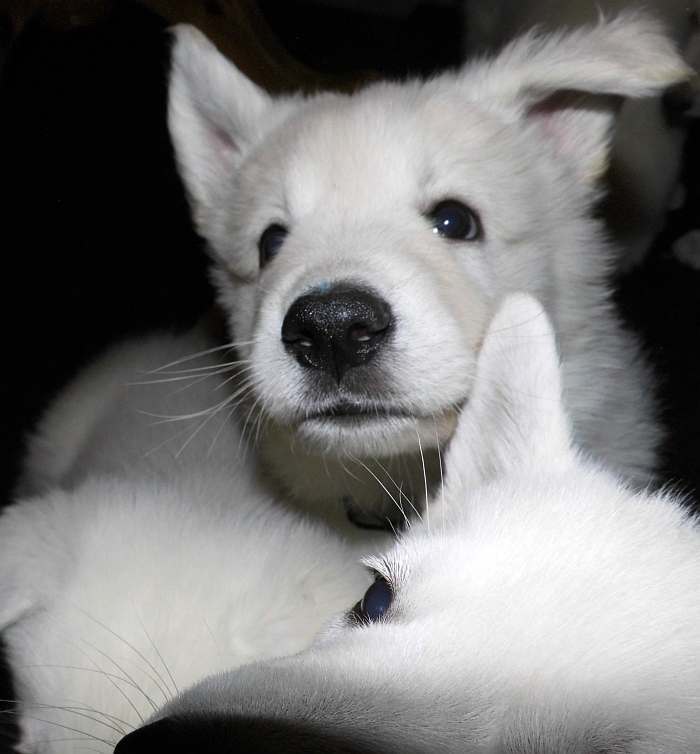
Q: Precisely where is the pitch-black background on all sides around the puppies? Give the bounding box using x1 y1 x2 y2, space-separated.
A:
0 0 700 752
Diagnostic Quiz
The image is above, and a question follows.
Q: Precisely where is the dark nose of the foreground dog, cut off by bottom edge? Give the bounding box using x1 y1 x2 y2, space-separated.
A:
114 715 386 754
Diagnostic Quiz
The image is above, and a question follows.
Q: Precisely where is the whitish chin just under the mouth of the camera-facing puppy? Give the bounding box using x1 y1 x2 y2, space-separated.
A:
295 409 457 458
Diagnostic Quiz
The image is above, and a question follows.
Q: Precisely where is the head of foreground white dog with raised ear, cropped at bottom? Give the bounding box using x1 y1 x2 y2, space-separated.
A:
117 296 700 754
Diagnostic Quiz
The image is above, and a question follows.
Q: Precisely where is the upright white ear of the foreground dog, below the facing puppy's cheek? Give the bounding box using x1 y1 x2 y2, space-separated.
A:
445 294 574 492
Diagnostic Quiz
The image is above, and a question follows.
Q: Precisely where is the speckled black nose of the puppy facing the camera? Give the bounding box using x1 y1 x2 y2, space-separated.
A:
282 285 393 381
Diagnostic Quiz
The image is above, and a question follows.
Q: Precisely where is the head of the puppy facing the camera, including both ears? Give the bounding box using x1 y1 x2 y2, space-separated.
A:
169 15 686 458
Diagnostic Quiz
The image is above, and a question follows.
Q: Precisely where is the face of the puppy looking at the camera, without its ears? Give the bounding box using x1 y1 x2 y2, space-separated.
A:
211 86 532 455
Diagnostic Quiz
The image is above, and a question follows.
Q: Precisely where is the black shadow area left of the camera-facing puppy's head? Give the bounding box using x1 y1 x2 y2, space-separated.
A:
0 6 210 506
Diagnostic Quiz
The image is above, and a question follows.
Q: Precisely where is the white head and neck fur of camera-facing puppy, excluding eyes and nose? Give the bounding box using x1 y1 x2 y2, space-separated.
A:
169 13 688 509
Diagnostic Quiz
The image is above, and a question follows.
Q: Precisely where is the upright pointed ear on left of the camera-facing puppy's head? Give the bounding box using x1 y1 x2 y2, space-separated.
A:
168 24 290 229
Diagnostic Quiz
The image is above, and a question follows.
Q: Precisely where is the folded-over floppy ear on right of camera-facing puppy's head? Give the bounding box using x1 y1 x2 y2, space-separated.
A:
465 11 692 181
